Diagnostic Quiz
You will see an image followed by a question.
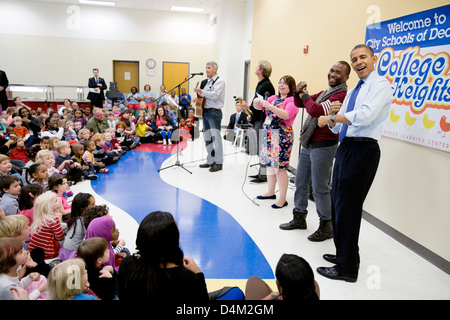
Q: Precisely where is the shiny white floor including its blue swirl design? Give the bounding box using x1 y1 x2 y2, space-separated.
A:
72 131 450 300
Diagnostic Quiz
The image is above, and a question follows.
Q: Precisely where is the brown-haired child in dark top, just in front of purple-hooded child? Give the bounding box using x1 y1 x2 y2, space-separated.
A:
77 237 117 300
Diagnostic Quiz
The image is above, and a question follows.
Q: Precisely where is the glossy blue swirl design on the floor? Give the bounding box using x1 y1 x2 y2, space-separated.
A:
91 151 274 279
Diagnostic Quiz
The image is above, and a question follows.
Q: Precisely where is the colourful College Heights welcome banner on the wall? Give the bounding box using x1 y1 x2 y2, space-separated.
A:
365 5 450 151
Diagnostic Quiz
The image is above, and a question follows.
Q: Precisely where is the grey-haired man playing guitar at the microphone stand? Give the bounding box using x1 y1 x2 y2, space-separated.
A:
194 61 225 172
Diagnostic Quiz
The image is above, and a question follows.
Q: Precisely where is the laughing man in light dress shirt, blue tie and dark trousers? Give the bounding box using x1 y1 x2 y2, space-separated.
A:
317 45 393 282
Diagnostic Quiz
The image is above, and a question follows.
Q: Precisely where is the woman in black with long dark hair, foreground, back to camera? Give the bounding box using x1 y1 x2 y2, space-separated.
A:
119 211 209 301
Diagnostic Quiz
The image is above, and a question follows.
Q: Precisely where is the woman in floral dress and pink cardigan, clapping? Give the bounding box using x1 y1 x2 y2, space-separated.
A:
253 76 298 209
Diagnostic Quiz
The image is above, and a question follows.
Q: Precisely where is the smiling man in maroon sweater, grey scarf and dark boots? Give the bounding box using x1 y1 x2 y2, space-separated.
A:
280 61 351 241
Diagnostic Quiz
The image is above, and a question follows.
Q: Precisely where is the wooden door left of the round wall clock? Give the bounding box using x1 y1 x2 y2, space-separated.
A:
112 61 141 97
